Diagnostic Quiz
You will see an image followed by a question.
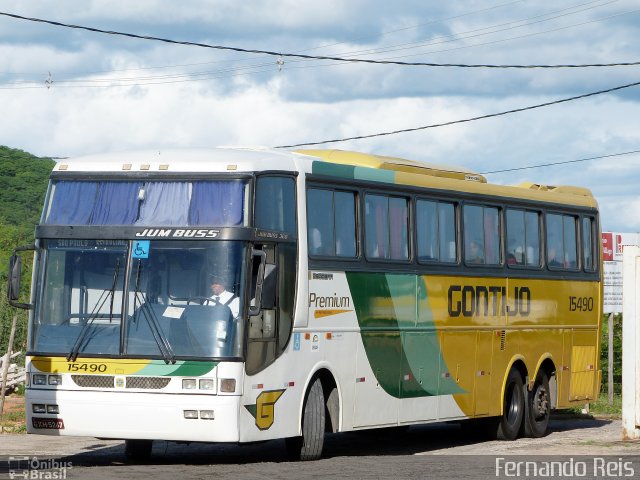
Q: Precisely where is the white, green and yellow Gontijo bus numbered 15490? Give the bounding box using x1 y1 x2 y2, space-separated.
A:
9 148 602 459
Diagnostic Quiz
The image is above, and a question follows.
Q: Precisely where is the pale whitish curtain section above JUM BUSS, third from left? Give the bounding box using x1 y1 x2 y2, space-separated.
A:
138 182 189 225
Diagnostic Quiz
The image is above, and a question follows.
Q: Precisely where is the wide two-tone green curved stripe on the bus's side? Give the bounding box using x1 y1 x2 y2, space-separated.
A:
346 272 464 398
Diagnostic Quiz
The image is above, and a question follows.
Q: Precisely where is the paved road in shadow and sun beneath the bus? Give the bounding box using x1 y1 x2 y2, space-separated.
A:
0 418 640 480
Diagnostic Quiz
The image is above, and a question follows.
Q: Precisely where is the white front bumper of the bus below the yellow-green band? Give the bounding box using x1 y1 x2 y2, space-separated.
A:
26 389 240 442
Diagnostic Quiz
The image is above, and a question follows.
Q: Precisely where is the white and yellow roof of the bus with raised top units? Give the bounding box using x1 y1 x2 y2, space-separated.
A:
54 147 597 208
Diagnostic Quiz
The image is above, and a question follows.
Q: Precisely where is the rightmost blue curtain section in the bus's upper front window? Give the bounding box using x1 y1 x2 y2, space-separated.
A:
189 181 244 226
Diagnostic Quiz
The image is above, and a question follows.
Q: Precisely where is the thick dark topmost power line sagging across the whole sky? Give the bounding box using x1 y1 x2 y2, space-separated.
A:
0 12 640 69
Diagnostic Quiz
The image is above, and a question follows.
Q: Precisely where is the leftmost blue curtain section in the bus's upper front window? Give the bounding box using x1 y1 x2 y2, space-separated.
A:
46 182 98 225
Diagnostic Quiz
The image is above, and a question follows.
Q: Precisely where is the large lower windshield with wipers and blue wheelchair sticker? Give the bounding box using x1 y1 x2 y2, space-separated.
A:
30 239 247 361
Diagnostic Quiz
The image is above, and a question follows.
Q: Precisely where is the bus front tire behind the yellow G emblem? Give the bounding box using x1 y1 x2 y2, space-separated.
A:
285 378 326 461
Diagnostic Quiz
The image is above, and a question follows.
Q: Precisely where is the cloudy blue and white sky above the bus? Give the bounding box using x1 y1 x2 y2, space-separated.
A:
0 0 640 232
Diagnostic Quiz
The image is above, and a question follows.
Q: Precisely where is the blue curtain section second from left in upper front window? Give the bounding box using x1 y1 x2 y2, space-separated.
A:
89 182 141 225
